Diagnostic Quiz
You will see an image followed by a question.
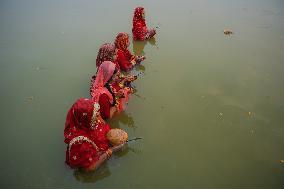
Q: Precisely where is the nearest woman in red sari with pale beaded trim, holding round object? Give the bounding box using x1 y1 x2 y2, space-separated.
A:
64 98 127 171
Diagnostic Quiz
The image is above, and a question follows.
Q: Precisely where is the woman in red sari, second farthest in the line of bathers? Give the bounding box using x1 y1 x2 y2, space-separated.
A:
114 32 145 72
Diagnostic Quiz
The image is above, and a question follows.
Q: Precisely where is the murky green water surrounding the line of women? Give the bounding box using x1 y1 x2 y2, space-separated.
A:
0 0 284 189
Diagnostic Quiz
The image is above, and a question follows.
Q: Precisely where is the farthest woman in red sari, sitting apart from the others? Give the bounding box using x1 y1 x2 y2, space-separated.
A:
132 7 156 41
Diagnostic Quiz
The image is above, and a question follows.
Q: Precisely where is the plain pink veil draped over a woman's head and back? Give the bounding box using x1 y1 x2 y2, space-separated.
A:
90 61 115 104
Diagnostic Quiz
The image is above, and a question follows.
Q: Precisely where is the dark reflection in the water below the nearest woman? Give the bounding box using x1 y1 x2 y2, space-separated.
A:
73 163 111 183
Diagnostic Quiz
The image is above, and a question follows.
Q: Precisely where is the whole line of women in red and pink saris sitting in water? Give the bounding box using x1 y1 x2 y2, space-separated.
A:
64 7 156 171
